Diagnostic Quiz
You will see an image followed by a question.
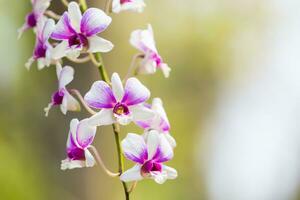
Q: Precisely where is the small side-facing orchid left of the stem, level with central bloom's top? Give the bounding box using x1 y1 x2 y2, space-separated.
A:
44 64 80 116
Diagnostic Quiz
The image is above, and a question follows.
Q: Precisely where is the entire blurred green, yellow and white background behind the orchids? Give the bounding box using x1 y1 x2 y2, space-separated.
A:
0 0 300 200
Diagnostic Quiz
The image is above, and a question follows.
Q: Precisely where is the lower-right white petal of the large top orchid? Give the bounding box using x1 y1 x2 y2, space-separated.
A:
88 35 114 53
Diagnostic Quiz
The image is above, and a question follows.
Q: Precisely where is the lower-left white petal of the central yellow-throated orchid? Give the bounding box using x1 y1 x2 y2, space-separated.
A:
89 109 115 126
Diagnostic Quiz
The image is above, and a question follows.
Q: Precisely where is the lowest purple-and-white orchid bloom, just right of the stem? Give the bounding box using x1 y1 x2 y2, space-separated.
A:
120 130 177 184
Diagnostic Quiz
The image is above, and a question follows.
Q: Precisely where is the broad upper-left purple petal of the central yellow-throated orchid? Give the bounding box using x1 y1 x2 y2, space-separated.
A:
84 81 116 109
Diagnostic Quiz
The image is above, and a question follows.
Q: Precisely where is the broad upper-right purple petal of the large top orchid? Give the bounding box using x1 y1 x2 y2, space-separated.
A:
80 8 111 37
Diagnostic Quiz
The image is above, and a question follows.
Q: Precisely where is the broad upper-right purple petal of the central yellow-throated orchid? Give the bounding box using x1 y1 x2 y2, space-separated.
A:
122 78 150 106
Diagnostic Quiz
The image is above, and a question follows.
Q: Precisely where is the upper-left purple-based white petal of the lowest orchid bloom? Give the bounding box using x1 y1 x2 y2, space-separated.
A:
121 133 147 164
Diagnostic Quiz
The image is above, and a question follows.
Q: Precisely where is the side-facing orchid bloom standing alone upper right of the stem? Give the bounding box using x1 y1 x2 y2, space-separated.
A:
130 24 171 78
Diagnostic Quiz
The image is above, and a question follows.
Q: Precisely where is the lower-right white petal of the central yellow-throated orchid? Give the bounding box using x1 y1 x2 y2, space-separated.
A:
130 104 155 121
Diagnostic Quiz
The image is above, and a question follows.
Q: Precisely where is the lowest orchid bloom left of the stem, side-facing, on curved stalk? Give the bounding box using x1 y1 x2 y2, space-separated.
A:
61 119 96 170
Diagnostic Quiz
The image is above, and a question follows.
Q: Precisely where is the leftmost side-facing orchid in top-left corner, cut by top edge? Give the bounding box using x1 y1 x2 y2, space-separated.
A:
18 0 51 38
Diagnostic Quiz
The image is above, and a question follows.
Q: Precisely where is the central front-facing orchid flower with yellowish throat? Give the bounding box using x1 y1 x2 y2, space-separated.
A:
84 73 154 126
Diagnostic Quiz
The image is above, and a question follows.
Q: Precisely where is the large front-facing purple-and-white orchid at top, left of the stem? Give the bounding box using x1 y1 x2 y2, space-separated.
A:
51 2 113 59
